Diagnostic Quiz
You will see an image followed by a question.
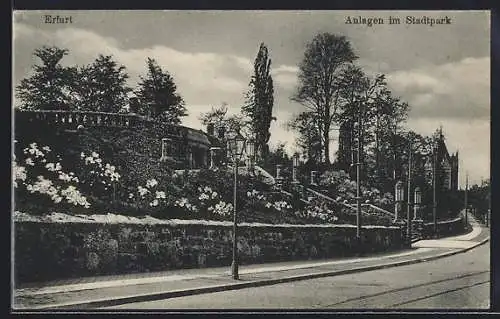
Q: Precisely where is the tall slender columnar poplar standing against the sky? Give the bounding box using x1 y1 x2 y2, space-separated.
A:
242 43 274 159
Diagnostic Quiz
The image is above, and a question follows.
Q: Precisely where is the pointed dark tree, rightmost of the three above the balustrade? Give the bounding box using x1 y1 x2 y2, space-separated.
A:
136 58 187 124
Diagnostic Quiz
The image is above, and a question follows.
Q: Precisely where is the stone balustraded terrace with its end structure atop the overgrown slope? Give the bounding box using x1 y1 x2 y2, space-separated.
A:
15 110 225 169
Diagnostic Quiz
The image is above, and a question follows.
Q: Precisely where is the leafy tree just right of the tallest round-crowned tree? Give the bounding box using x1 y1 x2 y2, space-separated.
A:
334 65 409 191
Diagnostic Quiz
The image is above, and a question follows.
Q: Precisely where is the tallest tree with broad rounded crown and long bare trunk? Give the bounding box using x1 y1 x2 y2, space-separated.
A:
292 33 357 164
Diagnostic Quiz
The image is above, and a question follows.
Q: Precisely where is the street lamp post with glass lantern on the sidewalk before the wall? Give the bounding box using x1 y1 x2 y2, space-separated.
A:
227 132 245 279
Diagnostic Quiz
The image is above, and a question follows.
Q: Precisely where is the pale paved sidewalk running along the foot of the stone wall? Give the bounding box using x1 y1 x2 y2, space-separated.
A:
13 218 489 310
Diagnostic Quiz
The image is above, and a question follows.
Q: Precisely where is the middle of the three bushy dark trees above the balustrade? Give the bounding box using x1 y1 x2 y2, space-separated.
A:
73 54 132 113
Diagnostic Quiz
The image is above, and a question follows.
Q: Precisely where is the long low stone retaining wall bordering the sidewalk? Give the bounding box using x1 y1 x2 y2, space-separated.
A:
14 222 403 285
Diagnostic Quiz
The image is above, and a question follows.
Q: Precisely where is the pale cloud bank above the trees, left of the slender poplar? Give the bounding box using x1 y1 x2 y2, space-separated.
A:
14 24 252 105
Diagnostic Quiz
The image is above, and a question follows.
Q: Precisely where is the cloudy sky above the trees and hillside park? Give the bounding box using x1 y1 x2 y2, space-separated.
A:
13 10 490 187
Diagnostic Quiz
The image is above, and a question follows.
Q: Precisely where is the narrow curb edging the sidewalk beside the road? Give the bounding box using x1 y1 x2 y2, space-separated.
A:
21 237 490 311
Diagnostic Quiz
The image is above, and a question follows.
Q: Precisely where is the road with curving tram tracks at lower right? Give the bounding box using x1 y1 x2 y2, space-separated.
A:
107 243 490 310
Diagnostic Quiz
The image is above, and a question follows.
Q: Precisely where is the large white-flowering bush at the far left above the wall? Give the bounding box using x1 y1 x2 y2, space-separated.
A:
13 143 90 209
